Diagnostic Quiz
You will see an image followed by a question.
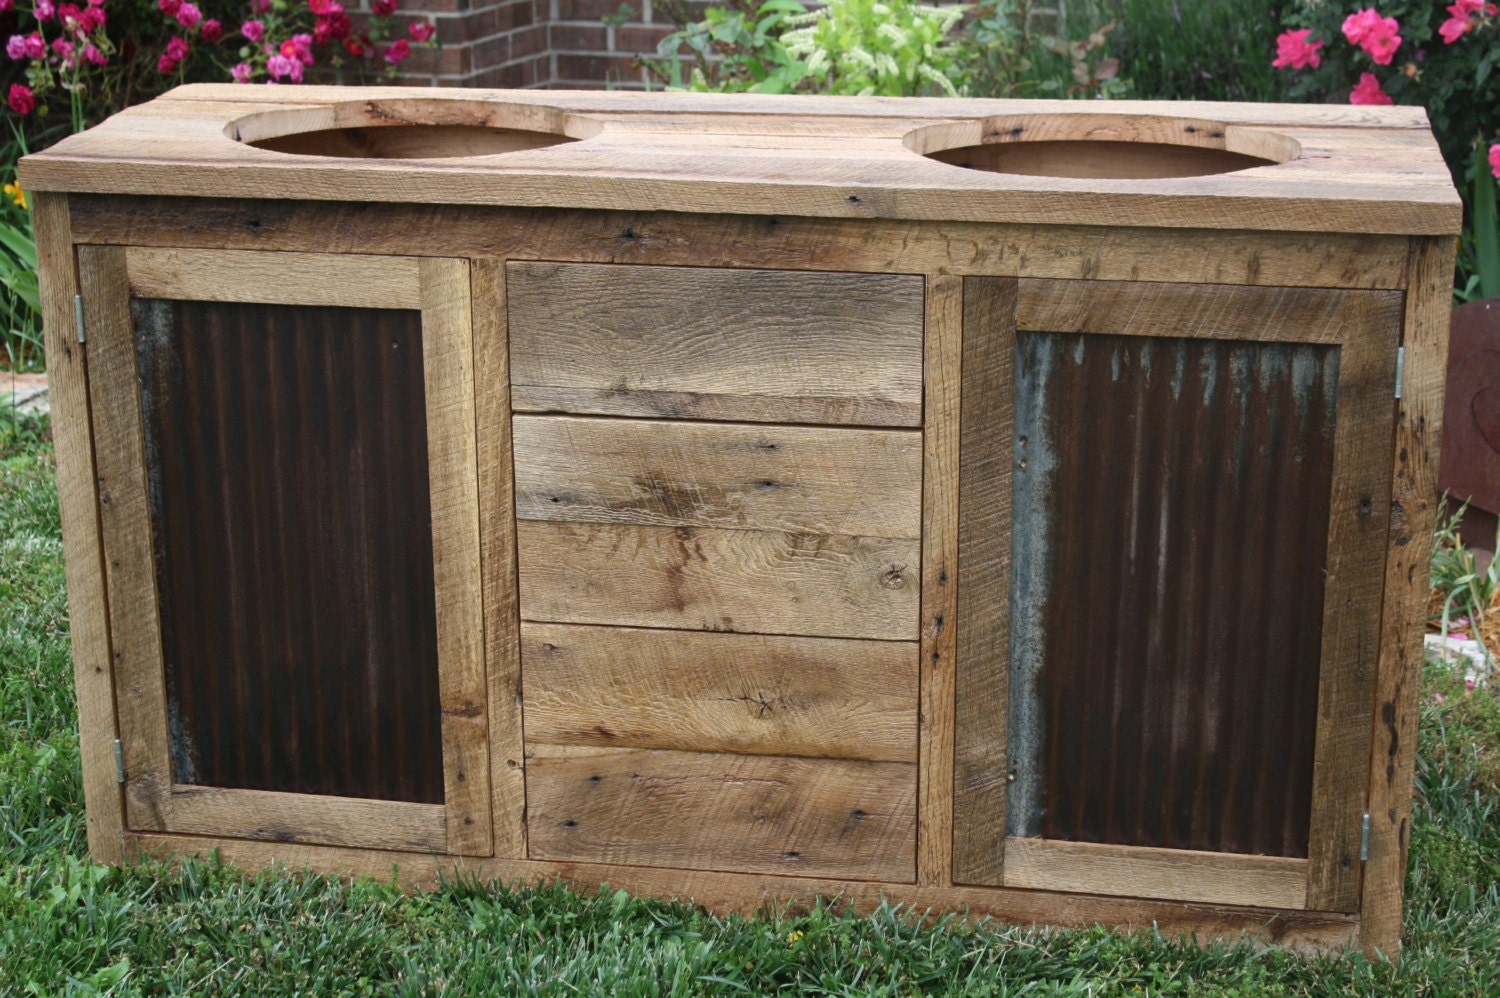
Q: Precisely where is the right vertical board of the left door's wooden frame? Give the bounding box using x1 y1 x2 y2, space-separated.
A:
419 260 492 855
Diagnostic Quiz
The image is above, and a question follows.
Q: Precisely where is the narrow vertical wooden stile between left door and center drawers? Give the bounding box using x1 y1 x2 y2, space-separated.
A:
470 258 527 858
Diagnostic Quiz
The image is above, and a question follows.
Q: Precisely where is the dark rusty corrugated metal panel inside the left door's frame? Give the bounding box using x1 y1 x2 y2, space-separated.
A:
134 300 443 803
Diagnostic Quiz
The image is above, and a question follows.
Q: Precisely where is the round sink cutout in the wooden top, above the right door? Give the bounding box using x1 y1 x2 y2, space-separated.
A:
906 114 1301 180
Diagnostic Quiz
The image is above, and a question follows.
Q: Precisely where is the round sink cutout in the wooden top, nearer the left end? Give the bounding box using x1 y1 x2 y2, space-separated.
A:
228 99 599 159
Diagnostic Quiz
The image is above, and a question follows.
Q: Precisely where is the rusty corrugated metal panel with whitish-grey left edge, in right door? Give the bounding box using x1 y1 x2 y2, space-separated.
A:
1007 332 1340 857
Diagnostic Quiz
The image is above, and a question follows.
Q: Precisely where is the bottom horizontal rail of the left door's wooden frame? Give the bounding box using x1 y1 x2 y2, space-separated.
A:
171 783 444 852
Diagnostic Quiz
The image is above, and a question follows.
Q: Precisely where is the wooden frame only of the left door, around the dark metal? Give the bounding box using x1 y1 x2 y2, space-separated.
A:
78 246 492 855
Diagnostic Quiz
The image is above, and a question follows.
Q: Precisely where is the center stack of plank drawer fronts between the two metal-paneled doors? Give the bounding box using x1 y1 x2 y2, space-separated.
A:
506 261 923 882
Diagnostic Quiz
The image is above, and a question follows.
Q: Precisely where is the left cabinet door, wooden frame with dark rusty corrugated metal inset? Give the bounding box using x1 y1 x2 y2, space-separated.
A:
78 246 491 855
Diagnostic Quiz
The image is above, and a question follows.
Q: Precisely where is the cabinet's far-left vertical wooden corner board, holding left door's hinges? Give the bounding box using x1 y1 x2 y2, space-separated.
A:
32 194 125 864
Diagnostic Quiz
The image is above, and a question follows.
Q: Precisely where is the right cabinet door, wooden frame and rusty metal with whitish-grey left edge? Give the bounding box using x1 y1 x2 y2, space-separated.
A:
954 279 1403 911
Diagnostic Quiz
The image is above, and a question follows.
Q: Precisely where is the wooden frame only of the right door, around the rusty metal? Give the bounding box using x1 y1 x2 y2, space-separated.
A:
954 278 1403 912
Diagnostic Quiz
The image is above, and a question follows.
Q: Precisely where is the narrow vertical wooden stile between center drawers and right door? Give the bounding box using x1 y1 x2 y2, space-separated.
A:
917 275 963 885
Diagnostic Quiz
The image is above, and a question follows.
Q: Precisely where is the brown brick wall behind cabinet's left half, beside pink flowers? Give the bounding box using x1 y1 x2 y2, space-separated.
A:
372 0 674 90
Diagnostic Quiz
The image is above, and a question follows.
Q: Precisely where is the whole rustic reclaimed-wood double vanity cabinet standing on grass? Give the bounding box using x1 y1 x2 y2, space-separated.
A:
23 86 1460 950
